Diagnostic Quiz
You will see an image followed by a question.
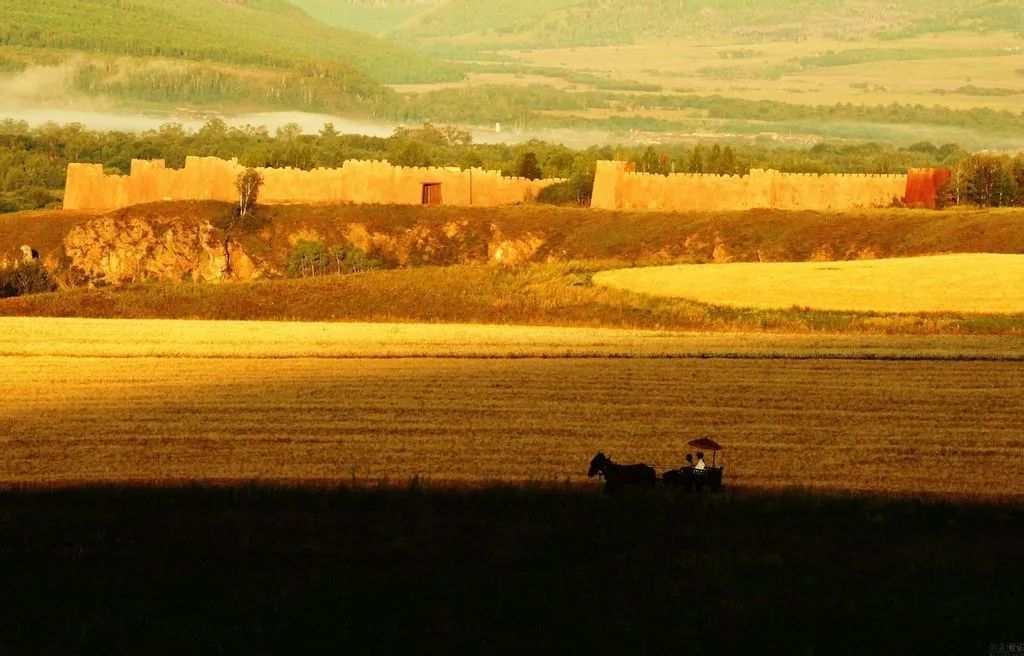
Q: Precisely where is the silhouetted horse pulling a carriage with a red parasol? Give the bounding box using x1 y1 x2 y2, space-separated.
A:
587 437 724 492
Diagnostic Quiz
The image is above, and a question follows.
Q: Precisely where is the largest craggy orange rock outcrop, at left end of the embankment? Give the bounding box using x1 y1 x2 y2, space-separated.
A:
63 215 266 285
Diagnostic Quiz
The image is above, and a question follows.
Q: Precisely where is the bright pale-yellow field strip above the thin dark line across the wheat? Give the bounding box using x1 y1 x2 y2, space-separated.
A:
0 317 1024 358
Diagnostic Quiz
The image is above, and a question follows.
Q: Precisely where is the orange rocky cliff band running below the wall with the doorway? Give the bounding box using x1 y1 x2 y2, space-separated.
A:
50 213 547 286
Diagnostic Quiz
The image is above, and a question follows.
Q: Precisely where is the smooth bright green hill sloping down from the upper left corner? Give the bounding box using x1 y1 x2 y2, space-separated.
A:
0 0 462 82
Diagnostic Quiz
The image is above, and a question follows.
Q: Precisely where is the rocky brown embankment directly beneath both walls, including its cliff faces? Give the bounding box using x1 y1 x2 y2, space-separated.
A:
6 203 966 287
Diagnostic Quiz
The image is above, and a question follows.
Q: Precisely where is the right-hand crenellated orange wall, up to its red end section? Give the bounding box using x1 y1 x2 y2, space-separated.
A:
591 162 907 211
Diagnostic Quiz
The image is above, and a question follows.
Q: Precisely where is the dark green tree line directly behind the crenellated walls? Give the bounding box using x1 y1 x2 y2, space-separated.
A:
0 118 1024 212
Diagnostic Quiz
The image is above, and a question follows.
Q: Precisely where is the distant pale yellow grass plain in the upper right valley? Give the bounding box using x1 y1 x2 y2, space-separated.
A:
511 33 1024 111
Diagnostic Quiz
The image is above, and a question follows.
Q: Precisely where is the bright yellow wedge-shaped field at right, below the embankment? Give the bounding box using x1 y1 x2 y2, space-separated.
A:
594 254 1024 314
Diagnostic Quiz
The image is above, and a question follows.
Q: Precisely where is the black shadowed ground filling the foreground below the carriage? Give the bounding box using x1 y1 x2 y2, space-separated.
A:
0 486 1024 654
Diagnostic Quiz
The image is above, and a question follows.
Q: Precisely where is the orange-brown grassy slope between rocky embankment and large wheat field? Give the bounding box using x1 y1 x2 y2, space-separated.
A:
0 261 1024 335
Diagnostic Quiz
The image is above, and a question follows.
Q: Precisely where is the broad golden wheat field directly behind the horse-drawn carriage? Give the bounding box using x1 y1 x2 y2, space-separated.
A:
0 319 1024 497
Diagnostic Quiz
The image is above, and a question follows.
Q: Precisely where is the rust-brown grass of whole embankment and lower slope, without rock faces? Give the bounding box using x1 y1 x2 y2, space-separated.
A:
6 203 1024 333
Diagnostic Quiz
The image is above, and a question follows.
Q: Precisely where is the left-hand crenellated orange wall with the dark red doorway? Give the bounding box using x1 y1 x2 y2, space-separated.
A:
63 157 560 210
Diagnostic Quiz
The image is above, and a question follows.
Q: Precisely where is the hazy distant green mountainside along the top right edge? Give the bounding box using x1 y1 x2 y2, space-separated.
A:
293 0 1024 48
